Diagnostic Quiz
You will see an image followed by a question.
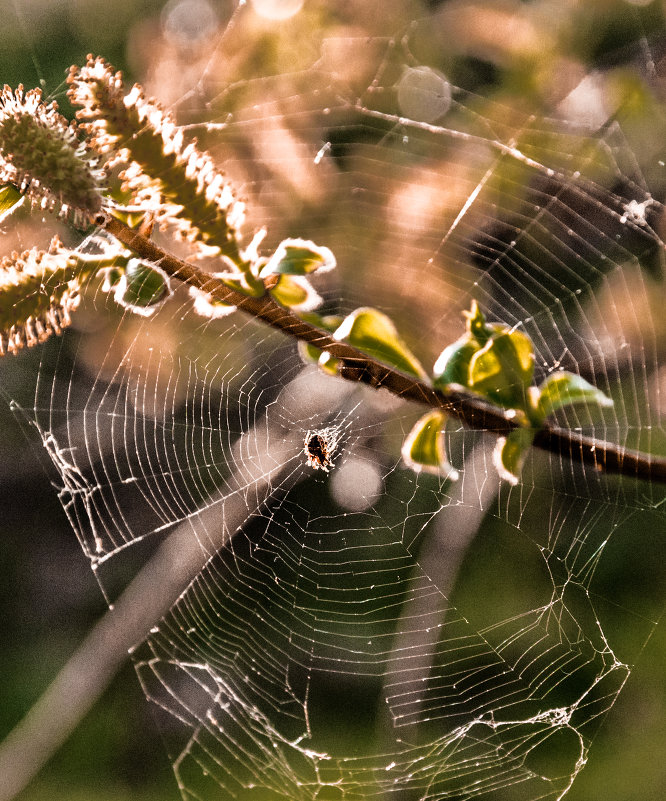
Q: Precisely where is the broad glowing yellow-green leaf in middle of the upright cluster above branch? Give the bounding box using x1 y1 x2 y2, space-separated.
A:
469 324 534 409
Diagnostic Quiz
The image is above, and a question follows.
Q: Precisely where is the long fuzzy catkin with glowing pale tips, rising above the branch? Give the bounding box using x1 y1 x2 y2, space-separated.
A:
68 56 247 270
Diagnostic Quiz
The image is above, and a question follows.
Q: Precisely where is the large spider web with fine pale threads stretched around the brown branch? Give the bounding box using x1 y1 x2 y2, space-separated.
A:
1 3 665 801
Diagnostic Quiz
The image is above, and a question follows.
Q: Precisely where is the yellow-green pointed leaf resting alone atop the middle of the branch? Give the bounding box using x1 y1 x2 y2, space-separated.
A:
334 308 428 379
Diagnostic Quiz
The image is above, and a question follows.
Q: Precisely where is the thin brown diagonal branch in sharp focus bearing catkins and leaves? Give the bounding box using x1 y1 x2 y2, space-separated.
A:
101 214 666 484
